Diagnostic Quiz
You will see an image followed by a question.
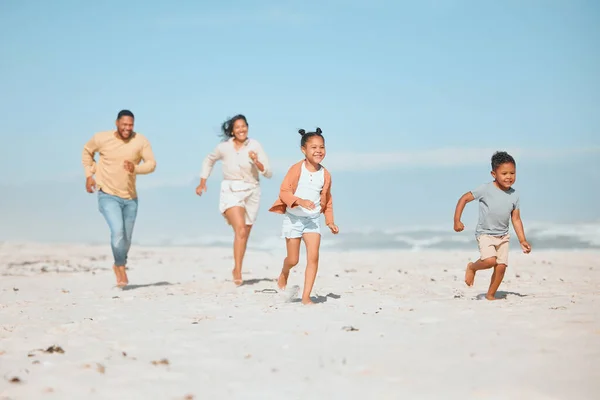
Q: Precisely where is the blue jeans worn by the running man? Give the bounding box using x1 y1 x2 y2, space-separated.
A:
98 190 138 267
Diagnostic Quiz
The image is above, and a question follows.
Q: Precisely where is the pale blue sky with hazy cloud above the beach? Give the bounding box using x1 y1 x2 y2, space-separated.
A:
0 0 600 245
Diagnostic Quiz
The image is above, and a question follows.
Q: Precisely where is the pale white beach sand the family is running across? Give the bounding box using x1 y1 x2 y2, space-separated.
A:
0 243 600 400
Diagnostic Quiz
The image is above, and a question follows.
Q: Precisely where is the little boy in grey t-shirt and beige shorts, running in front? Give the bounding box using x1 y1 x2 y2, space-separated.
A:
454 151 531 300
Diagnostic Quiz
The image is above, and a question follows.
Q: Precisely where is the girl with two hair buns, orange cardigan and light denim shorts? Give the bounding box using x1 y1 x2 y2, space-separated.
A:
269 128 339 304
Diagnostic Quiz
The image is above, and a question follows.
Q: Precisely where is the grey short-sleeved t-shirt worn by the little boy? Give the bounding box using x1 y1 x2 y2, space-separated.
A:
471 182 519 236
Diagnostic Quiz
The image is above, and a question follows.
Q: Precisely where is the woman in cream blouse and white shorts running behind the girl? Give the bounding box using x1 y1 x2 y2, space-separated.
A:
196 114 272 286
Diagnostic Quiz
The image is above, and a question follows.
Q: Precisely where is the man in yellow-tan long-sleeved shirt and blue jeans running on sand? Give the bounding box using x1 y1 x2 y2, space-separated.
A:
81 110 156 287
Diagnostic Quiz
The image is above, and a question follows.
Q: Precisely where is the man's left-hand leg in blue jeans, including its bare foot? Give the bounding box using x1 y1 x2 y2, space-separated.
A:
98 192 125 286
